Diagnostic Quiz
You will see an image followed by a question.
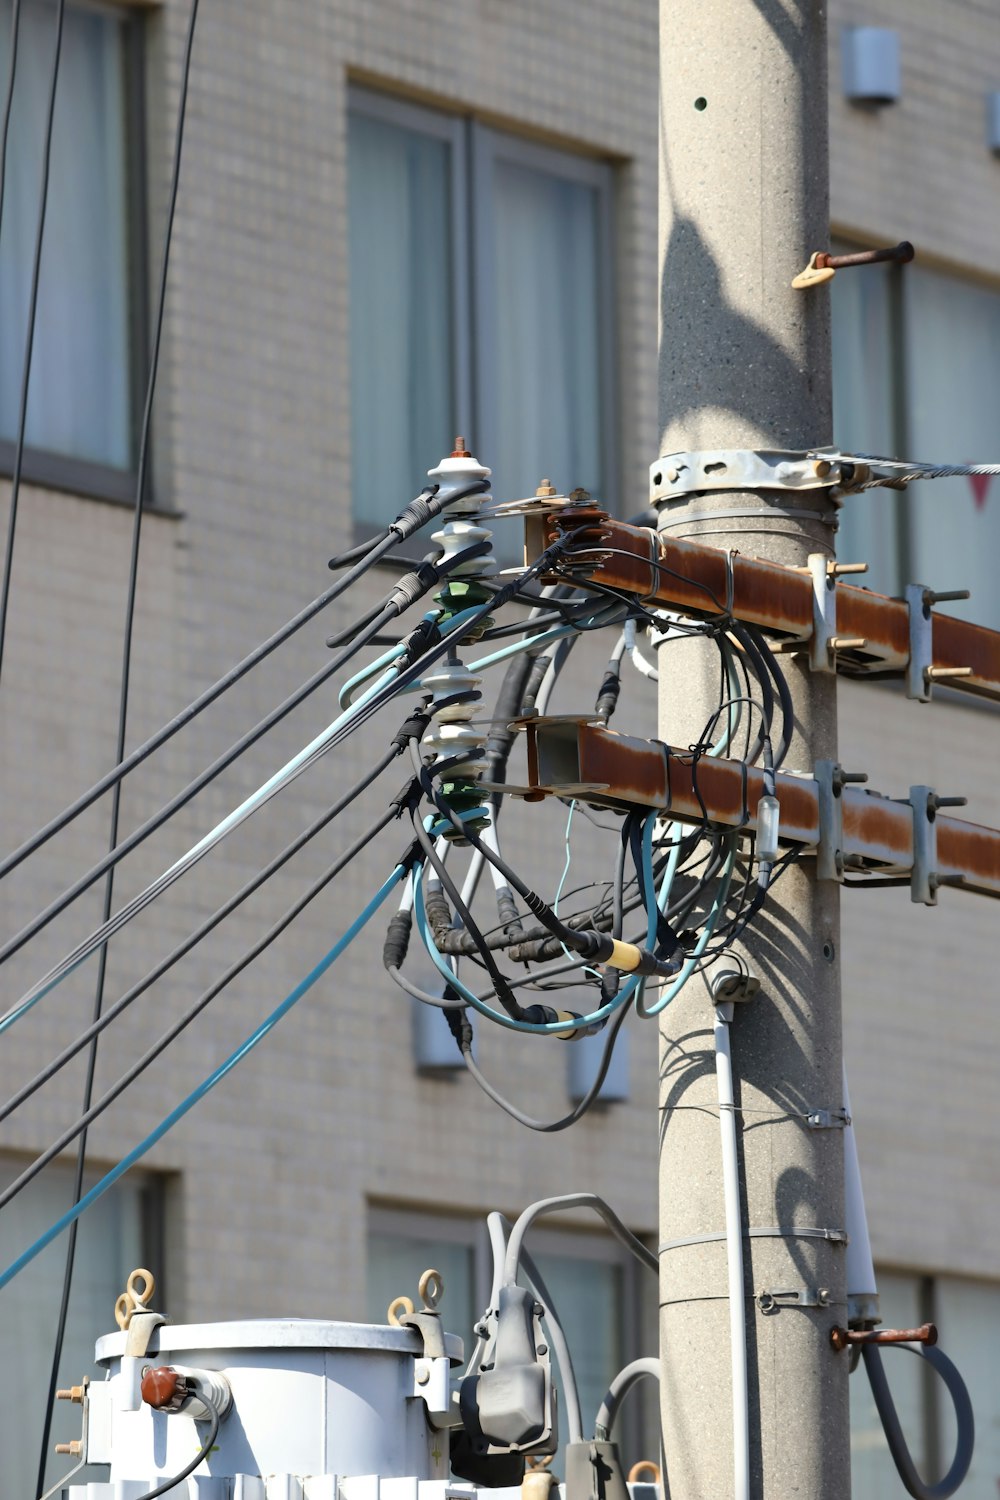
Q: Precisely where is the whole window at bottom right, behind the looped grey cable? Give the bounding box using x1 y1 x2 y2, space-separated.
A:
850 1271 1000 1500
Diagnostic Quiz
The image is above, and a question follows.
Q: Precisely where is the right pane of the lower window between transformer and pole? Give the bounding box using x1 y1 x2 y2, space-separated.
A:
532 1251 620 1478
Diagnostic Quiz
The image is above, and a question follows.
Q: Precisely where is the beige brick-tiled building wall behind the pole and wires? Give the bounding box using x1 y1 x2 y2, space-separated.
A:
0 0 1000 1362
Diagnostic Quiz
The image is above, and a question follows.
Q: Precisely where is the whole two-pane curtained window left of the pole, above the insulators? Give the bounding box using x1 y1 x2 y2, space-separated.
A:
348 89 616 549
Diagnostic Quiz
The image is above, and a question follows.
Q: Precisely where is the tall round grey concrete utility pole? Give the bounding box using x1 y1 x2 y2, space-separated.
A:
660 0 850 1500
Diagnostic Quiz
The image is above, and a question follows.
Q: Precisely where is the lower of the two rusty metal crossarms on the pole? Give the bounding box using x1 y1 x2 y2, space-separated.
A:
505 717 1000 900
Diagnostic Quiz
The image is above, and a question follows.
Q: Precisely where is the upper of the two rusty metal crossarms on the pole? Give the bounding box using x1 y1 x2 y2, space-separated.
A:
525 506 1000 702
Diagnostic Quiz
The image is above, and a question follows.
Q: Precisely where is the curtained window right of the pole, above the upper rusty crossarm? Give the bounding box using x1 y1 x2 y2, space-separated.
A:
832 246 1000 629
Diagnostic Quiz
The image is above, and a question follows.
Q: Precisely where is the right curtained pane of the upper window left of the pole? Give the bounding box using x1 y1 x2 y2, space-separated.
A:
491 156 607 500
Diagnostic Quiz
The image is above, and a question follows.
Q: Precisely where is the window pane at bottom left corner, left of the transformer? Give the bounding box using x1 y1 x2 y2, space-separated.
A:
0 1158 150 1496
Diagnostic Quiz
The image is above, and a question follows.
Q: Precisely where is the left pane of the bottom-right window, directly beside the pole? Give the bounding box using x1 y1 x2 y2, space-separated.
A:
850 1271 925 1500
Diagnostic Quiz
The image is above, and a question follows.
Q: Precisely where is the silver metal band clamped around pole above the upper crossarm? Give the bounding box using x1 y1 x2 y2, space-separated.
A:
649 449 841 506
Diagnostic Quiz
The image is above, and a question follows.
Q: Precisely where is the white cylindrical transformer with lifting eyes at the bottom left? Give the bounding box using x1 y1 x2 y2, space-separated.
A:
67 1319 462 1500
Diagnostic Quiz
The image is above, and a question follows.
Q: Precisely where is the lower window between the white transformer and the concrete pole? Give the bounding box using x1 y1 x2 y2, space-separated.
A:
366 1208 660 1473
